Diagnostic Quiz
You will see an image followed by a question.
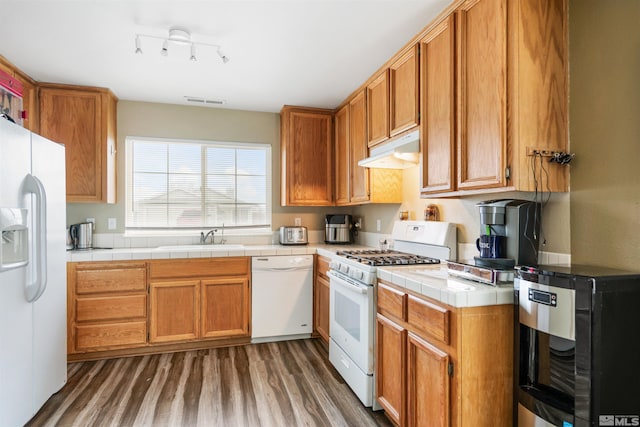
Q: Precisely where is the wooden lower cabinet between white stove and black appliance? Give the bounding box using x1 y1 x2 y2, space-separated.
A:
375 282 513 427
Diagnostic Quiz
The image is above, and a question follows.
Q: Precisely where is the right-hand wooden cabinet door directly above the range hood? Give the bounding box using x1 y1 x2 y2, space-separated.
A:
389 45 419 136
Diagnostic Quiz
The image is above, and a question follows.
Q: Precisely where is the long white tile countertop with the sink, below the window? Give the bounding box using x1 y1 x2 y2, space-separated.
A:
67 243 366 262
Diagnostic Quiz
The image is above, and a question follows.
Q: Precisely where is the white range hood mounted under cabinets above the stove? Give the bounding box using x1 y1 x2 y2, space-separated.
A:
358 130 420 169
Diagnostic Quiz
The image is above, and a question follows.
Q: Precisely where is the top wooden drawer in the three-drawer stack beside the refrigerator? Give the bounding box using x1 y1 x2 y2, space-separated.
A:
76 264 147 294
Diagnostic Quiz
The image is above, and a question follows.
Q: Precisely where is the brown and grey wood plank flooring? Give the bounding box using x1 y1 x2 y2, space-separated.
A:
27 339 392 427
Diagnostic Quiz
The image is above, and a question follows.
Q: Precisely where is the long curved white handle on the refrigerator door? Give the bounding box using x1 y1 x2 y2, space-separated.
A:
23 174 47 302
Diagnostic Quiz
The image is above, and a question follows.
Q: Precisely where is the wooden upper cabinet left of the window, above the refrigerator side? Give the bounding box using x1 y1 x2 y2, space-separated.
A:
39 84 117 203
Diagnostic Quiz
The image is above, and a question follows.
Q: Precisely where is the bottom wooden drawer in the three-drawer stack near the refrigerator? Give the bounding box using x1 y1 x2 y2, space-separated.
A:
76 320 147 351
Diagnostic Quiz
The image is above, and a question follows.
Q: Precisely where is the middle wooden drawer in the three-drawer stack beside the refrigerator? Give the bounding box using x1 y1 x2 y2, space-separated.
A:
76 294 147 322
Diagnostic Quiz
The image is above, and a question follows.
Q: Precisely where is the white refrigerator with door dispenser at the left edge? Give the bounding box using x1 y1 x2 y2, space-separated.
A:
0 119 67 427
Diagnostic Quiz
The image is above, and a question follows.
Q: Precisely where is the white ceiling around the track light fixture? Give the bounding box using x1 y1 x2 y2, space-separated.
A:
0 0 451 112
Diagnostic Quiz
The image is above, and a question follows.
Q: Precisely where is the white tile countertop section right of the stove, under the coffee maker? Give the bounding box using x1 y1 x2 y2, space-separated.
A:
376 263 514 307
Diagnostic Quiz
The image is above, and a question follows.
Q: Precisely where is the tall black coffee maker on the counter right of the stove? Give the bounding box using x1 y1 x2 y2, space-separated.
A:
474 199 541 270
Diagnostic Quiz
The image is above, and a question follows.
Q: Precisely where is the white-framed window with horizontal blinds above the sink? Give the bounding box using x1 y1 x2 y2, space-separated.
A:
125 137 271 231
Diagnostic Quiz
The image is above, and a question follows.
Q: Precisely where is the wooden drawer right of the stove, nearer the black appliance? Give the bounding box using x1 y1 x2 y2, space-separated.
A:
407 295 451 344
